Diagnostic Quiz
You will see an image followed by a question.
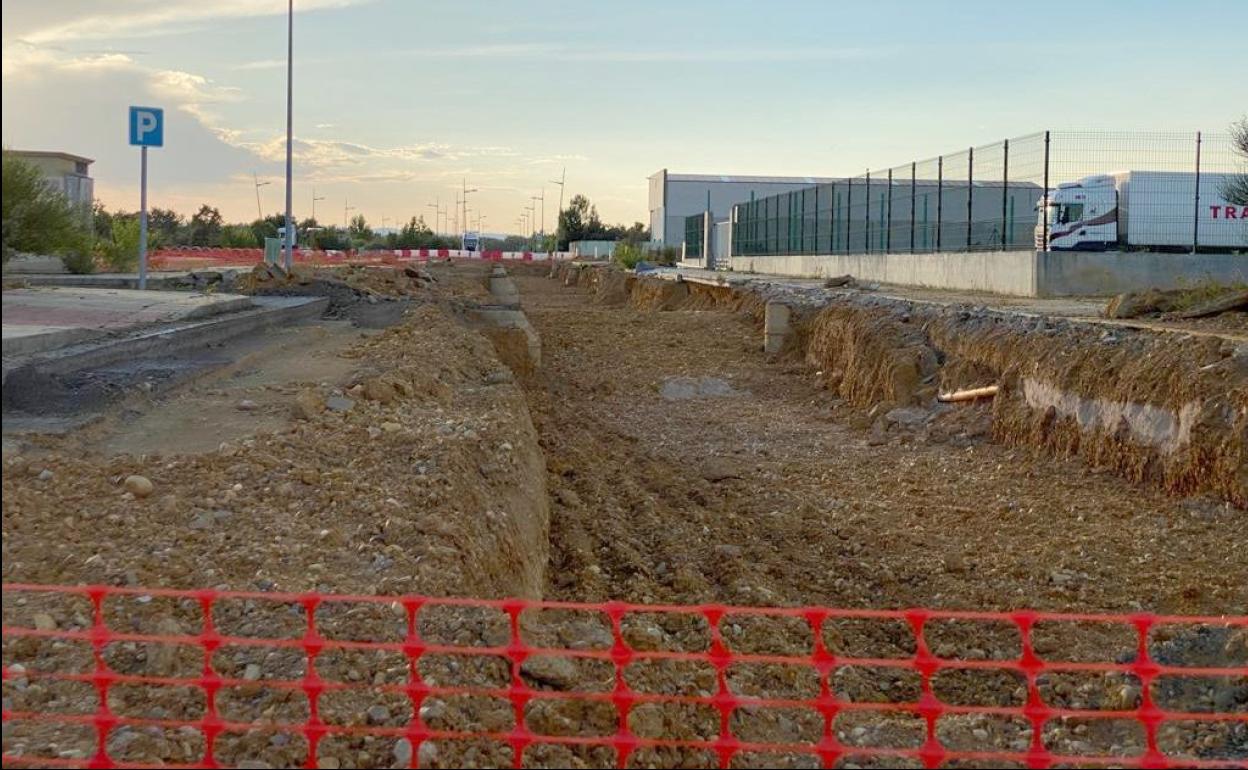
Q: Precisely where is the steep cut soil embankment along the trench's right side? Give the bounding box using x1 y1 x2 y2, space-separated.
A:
563 260 1248 507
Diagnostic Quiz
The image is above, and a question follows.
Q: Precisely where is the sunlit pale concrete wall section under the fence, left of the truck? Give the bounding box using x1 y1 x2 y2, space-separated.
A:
731 251 1036 297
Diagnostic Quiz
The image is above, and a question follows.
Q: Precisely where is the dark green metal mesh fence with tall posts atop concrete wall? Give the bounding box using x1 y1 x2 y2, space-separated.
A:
733 131 1248 256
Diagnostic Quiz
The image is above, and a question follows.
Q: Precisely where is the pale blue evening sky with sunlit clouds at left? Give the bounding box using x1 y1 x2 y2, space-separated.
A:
0 0 1248 232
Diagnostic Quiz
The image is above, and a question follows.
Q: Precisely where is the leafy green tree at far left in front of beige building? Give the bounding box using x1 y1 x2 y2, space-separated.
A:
0 152 91 272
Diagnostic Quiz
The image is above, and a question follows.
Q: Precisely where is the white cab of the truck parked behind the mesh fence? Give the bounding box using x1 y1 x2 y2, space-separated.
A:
1036 175 1118 251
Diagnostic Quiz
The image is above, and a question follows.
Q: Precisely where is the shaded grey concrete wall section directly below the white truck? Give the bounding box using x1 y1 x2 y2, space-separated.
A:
1036 251 1248 297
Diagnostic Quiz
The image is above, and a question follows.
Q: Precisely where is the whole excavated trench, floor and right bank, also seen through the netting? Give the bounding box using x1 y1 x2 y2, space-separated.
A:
441 266 1248 766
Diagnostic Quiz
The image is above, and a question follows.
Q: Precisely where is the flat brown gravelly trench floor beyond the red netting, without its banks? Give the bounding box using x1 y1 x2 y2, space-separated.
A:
519 277 1248 613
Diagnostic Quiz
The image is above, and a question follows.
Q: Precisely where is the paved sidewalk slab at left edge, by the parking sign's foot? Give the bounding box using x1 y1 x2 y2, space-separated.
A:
2 287 252 357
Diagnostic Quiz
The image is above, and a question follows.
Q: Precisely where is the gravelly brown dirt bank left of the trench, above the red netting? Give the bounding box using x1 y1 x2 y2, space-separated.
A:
4 306 548 597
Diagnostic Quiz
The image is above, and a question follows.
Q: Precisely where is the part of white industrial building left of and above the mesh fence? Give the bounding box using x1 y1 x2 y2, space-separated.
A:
650 168 841 246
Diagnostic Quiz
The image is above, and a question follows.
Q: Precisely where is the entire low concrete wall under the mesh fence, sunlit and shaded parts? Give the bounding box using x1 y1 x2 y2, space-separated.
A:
731 251 1248 297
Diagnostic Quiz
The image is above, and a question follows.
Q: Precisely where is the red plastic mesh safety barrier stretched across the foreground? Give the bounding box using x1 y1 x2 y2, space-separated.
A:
4 583 1248 768
